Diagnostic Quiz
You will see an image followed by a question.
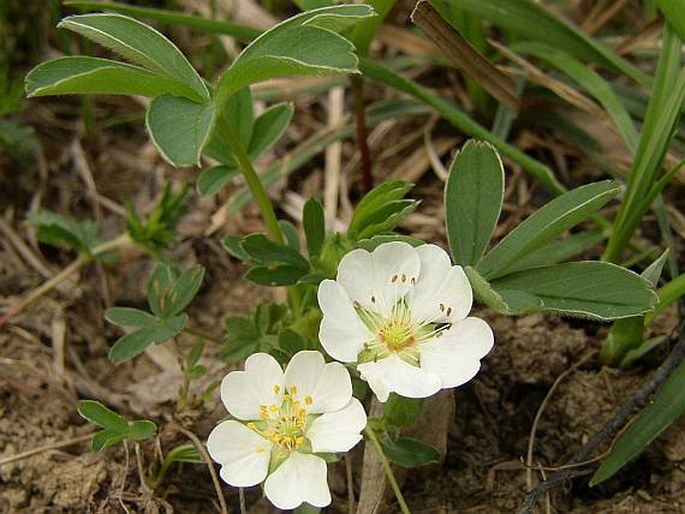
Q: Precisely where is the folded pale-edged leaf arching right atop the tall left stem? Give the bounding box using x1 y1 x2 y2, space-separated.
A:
216 4 373 104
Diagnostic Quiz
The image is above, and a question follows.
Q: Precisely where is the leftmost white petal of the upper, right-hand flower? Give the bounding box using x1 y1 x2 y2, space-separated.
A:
318 280 372 362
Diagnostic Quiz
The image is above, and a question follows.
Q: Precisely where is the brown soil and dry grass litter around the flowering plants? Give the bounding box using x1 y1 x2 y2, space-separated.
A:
0 1 685 508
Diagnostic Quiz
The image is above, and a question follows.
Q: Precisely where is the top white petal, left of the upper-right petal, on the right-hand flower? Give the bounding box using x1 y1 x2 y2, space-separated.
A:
372 241 421 315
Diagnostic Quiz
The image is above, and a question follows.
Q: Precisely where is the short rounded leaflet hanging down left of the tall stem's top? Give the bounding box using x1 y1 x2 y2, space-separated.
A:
145 95 214 167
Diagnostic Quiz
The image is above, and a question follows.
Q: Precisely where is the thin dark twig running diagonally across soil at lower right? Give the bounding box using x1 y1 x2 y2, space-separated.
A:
519 321 685 514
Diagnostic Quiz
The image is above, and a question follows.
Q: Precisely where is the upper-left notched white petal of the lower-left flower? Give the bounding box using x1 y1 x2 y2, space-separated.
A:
221 353 283 420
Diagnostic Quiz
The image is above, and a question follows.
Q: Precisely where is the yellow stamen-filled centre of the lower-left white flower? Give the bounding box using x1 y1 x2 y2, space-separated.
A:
247 385 314 452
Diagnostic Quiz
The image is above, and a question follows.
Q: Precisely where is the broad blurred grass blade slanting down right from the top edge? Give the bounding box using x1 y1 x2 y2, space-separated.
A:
431 0 649 84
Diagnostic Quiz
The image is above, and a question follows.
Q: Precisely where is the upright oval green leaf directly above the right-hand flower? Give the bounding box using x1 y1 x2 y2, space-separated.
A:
445 140 504 266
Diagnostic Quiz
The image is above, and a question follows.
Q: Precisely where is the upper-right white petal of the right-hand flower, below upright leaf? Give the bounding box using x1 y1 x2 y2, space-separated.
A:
410 245 473 323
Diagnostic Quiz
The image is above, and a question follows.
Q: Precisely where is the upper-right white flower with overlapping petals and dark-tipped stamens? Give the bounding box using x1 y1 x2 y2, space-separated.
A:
318 242 494 402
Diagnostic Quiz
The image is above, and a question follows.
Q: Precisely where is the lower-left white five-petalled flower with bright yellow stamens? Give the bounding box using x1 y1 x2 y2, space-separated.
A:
207 351 366 509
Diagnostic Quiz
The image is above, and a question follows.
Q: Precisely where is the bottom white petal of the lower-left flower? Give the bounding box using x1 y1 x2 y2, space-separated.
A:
264 452 331 510
